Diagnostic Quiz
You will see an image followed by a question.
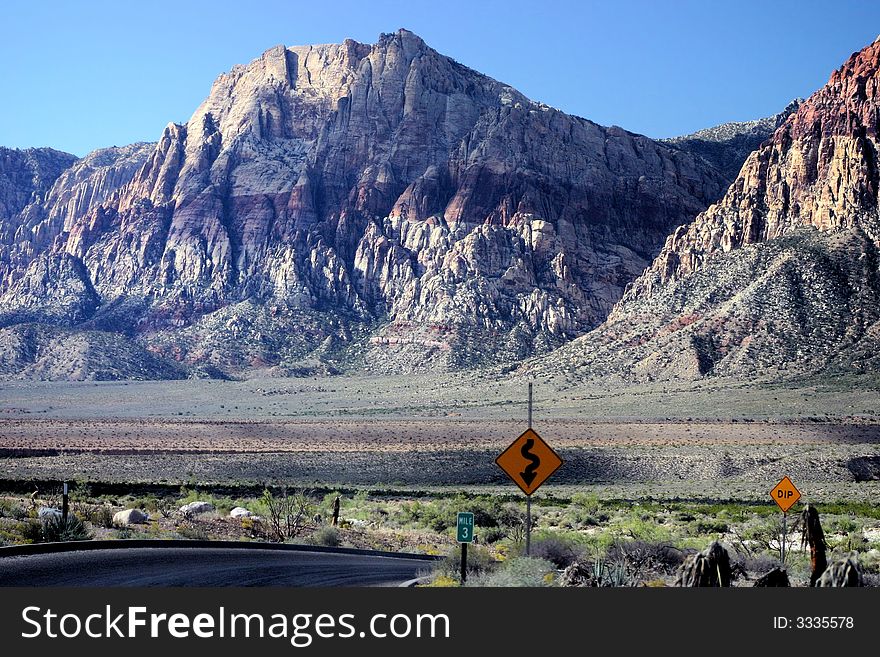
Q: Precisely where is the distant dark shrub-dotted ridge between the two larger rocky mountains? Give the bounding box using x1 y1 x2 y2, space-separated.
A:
661 98 804 182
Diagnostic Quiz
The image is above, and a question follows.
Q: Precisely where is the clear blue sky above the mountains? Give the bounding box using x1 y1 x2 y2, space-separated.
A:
0 0 880 155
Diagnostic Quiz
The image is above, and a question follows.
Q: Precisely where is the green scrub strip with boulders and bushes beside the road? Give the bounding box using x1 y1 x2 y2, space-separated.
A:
0 486 880 586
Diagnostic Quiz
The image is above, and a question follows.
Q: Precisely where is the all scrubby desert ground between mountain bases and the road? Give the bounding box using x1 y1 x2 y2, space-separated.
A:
0 373 880 586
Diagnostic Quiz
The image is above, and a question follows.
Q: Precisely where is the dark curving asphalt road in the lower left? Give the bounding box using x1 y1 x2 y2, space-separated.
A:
0 548 431 586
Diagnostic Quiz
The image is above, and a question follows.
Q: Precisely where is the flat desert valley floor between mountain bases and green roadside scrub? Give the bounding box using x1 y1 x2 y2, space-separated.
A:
0 374 880 503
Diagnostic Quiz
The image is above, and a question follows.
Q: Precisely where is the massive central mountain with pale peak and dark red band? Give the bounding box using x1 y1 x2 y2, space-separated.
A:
0 30 725 376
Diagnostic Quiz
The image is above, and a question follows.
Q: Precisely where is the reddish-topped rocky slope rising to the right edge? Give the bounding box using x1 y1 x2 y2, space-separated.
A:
531 39 880 380
